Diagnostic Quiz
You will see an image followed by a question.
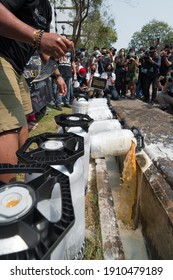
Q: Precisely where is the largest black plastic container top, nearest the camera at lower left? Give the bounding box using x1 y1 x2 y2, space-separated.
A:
0 164 75 260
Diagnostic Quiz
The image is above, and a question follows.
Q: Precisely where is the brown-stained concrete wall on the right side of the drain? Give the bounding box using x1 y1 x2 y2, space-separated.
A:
138 154 173 260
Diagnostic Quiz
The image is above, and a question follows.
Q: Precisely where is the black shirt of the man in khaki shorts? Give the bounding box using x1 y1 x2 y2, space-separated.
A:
0 0 52 74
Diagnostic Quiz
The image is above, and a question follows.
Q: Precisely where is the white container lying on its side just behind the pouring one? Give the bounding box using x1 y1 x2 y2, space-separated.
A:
89 119 122 135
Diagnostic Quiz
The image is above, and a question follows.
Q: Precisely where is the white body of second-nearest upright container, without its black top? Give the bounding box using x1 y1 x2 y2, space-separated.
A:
24 147 86 260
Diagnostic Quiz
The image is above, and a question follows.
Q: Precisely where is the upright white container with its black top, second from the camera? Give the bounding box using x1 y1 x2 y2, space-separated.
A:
17 133 85 260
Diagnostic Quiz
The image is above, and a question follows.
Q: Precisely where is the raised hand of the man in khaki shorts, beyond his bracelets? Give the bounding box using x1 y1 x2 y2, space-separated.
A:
40 32 73 59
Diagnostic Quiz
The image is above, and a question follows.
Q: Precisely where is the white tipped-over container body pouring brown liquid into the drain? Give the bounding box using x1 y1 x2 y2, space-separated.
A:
91 129 134 159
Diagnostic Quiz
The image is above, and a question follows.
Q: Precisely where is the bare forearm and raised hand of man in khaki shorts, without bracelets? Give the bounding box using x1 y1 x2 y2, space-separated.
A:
0 3 73 58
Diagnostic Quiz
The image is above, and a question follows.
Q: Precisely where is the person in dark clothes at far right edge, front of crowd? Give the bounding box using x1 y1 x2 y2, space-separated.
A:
157 71 173 111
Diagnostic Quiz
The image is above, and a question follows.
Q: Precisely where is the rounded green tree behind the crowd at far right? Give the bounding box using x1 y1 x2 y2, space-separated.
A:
129 20 173 49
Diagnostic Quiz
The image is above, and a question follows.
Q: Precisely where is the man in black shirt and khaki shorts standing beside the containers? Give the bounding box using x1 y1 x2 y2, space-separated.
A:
0 0 71 182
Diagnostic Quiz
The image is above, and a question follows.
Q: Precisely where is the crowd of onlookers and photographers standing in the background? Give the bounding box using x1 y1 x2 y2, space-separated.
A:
49 44 173 110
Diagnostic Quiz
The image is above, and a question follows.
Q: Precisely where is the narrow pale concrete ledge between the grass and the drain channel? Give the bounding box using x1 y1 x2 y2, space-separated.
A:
95 159 125 260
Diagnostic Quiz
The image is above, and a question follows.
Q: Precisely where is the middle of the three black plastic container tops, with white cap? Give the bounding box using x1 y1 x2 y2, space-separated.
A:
17 132 84 173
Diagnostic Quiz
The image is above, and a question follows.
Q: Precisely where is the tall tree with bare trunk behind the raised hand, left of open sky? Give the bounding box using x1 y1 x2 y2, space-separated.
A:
49 0 117 48
